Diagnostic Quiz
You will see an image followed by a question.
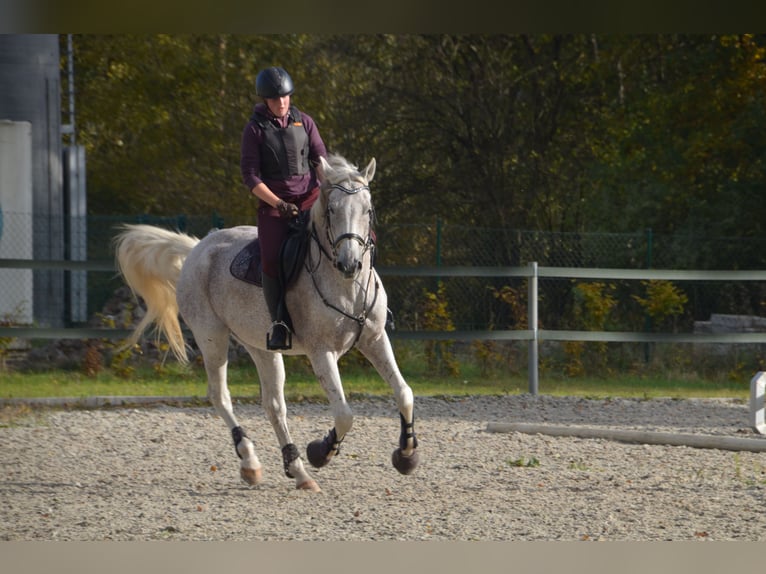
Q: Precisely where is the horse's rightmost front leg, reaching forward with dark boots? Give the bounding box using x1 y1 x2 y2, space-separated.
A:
357 332 420 474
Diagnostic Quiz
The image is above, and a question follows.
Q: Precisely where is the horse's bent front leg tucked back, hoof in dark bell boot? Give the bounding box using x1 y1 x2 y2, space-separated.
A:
306 353 354 468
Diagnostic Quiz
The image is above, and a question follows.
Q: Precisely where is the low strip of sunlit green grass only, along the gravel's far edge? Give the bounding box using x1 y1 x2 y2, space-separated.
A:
0 357 750 401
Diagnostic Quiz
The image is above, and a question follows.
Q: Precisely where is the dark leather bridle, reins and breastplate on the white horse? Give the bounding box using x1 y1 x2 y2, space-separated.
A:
305 183 380 345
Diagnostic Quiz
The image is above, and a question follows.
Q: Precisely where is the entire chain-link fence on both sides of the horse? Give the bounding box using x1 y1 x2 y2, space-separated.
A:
0 213 766 338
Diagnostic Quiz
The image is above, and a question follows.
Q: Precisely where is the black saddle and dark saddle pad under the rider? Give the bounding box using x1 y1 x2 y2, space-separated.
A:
229 211 310 290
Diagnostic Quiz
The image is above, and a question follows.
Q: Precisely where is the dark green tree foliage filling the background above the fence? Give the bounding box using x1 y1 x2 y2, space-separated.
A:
69 34 766 243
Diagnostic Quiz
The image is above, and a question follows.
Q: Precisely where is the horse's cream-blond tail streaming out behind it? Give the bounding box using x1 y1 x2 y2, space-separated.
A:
114 224 199 363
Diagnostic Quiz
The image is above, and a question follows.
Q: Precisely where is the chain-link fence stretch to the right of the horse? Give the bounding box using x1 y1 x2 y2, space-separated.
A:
378 222 766 331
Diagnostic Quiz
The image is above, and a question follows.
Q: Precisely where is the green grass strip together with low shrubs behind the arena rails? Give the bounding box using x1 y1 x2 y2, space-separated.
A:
0 341 763 401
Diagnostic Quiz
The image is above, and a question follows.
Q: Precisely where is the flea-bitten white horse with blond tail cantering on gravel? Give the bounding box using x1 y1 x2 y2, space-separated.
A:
114 154 419 492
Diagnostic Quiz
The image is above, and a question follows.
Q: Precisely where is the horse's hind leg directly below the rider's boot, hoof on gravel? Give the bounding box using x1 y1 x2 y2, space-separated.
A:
248 348 321 492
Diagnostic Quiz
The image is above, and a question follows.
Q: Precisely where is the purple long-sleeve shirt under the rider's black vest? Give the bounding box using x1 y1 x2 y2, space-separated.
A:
240 103 327 201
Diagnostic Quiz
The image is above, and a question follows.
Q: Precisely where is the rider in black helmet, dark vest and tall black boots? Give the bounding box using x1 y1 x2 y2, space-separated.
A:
240 67 327 349
